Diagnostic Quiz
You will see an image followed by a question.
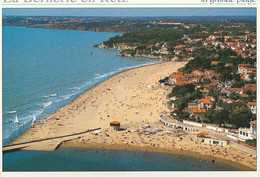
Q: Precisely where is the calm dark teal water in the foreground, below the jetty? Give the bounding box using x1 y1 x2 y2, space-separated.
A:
3 148 240 171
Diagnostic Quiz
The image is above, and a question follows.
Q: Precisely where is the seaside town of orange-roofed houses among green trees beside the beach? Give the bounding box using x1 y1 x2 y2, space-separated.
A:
96 18 257 169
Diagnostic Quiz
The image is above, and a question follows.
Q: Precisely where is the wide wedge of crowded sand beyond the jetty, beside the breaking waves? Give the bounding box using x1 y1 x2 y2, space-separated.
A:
13 62 184 143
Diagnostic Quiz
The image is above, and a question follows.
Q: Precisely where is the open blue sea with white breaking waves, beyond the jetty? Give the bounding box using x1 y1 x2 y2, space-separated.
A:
2 26 158 144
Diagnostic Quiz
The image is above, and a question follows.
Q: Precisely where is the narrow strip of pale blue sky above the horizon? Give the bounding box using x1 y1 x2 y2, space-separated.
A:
3 8 256 17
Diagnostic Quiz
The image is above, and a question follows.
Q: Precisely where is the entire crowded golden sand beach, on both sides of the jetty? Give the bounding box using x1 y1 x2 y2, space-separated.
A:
12 62 256 170
